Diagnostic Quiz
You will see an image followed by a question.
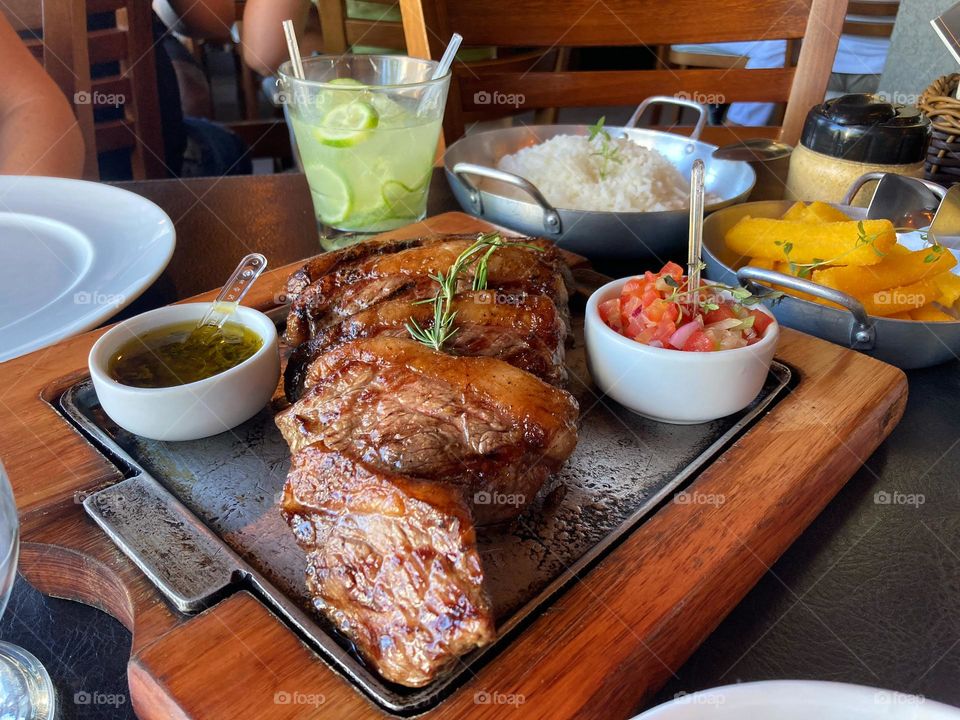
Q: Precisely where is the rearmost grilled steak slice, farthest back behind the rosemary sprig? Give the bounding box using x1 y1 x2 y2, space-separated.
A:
286 238 571 346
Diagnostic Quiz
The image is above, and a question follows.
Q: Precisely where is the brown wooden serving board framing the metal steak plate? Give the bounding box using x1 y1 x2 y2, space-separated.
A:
0 213 907 720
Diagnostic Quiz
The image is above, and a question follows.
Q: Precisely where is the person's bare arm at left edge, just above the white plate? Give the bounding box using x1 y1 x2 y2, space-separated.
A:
0 13 84 178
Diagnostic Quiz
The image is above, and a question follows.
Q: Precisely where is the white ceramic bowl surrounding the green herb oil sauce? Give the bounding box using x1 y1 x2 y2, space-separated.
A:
88 303 280 440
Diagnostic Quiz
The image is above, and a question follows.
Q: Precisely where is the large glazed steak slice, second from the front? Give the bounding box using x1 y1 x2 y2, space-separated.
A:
276 337 577 525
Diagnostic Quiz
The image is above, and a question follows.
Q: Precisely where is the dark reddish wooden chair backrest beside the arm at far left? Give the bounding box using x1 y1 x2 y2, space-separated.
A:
0 0 168 179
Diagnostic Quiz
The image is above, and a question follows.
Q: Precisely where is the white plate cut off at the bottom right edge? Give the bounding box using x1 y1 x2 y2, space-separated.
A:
634 680 960 720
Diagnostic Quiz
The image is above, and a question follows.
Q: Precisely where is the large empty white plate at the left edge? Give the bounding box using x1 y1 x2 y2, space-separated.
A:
0 176 176 362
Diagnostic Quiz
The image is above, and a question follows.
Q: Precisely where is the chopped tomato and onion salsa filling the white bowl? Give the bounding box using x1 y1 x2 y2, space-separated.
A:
599 262 773 352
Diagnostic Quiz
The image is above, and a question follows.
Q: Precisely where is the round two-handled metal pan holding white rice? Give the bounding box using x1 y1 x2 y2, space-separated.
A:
444 97 756 263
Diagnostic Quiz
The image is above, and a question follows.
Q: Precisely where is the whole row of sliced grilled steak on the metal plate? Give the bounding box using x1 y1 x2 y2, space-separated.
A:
276 235 578 687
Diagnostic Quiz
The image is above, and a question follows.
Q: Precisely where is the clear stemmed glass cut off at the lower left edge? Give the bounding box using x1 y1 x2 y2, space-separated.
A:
0 464 56 720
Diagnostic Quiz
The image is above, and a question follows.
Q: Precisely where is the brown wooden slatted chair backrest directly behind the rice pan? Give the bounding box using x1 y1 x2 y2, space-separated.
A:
400 0 846 143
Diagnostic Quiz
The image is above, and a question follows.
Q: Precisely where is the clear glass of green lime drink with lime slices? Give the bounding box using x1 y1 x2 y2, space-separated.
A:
278 55 450 250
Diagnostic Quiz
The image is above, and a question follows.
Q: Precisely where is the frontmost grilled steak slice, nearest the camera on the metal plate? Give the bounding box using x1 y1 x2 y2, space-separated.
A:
282 444 495 687
